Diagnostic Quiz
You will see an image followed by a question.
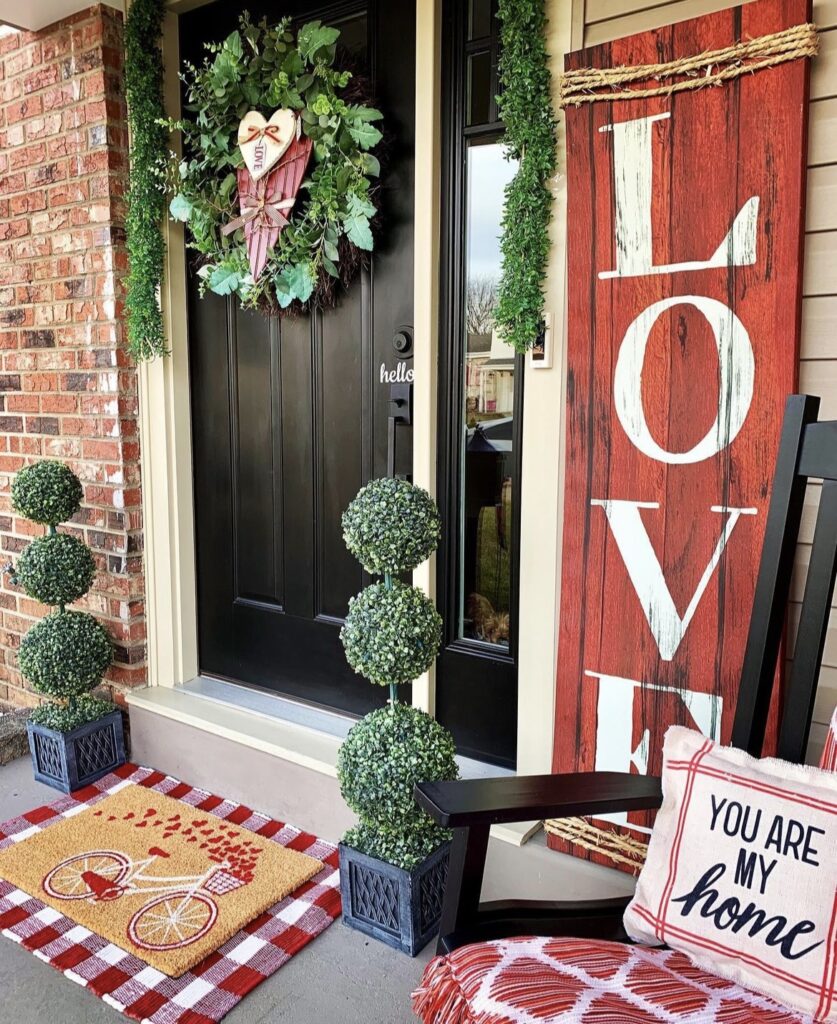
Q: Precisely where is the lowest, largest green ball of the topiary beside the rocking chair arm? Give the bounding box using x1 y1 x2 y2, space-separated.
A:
337 703 458 831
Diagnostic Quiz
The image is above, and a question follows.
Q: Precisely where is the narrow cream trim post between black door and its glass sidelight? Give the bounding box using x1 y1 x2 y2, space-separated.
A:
413 0 442 715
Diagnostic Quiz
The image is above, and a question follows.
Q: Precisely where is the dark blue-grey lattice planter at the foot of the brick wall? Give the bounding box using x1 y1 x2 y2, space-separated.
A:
27 711 125 793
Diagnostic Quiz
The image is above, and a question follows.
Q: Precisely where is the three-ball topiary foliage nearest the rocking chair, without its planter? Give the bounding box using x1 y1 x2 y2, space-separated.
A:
337 477 458 870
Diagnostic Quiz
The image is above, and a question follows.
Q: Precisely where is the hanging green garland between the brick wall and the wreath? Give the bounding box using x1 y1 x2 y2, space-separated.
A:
125 0 166 360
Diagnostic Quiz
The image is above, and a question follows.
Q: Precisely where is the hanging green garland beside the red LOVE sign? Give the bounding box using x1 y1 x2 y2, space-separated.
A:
494 0 555 352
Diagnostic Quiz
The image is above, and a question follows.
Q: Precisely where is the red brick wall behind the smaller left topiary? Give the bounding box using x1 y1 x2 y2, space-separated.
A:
0 6 145 705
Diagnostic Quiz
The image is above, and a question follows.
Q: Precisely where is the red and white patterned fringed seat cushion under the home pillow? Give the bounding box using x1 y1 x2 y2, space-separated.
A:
413 938 812 1024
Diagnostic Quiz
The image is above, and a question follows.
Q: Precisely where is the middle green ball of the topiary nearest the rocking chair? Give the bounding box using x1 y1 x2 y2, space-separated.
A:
340 581 442 686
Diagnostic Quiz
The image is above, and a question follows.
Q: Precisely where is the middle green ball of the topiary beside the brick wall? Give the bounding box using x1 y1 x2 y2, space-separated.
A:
14 534 96 604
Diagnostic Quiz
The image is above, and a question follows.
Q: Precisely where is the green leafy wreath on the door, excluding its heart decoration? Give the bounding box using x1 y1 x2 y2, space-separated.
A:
162 13 382 311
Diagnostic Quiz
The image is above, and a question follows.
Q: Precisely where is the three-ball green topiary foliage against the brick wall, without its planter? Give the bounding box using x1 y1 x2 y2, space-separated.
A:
11 462 114 732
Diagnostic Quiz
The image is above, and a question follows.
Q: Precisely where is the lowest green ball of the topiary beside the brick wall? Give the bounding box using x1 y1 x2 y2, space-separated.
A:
18 611 114 697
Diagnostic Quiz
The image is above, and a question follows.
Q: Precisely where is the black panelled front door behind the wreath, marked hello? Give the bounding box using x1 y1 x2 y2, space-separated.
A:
180 0 415 714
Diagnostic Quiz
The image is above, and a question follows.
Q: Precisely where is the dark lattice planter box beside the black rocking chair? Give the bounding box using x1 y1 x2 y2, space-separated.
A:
340 843 451 956
